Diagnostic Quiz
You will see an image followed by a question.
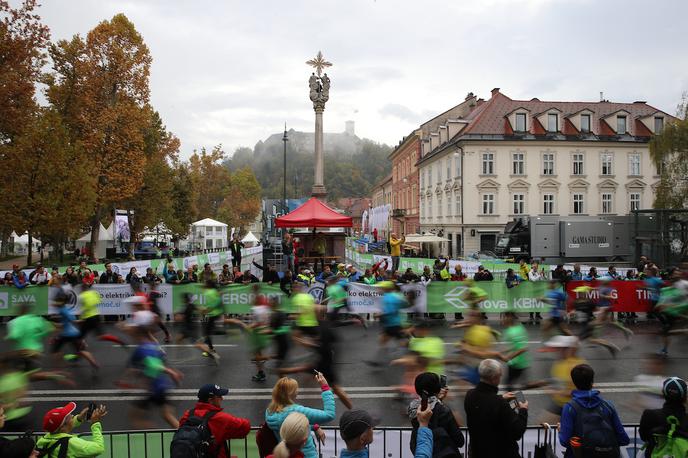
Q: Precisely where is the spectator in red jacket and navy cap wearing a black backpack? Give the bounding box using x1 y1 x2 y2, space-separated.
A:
179 383 251 458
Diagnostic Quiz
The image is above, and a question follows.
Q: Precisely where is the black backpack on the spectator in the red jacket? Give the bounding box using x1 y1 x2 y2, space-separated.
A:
170 409 217 458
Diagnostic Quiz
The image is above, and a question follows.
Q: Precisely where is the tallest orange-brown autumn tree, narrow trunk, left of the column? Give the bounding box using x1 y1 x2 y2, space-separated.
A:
46 14 151 262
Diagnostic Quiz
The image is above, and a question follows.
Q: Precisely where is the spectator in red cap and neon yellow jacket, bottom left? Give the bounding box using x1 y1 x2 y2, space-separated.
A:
36 402 107 458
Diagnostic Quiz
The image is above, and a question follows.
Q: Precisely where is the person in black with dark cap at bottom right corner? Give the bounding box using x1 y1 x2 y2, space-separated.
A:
638 377 688 458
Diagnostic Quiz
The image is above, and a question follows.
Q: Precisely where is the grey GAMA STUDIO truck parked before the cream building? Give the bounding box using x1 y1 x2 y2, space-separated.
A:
495 216 632 264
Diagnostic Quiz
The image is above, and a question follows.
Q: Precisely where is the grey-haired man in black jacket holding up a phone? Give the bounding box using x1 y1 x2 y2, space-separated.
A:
464 359 528 458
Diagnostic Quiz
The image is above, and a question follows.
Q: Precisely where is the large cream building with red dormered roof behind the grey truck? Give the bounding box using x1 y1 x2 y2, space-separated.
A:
418 88 672 256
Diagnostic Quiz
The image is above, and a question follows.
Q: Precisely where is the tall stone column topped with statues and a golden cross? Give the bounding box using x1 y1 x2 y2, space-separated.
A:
306 51 332 199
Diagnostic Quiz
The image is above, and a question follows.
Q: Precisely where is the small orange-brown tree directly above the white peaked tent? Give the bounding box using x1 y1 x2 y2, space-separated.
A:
189 145 231 218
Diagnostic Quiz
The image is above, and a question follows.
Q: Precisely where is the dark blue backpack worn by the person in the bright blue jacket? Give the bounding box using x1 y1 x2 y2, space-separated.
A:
569 401 621 458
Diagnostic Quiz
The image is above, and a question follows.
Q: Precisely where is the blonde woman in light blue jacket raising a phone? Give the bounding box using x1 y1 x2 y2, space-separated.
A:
265 372 336 458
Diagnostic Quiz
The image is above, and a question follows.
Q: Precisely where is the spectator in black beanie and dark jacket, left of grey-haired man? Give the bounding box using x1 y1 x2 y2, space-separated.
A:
408 372 465 458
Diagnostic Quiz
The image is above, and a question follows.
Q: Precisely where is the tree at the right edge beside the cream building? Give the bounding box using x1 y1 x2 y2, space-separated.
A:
650 93 688 209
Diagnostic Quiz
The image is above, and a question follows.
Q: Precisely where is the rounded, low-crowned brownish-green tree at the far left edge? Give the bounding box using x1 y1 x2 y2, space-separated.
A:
0 108 95 265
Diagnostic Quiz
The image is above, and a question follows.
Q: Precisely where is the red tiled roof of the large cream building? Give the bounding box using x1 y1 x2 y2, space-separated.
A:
459 92 671 135
